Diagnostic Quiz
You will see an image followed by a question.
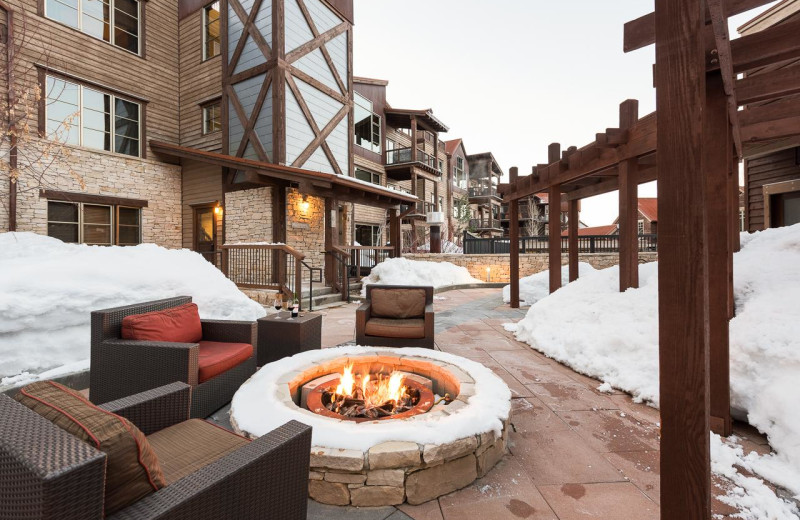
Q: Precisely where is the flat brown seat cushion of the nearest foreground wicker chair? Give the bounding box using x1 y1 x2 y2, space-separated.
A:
147 419 250 484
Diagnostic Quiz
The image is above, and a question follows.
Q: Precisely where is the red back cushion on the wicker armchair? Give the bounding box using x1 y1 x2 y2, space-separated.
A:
122 303 203 343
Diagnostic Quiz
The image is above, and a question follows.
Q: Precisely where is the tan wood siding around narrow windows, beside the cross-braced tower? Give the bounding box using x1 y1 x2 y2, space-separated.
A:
179 9 222 152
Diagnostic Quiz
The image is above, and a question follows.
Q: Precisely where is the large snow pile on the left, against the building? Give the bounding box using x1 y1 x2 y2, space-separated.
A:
0 233 265 386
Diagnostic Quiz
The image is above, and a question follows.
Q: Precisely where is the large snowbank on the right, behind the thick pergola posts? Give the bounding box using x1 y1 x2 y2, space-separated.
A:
516 225 800 518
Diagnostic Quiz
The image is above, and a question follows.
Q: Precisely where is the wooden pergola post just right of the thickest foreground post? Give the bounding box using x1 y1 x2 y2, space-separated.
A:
702 72 733 436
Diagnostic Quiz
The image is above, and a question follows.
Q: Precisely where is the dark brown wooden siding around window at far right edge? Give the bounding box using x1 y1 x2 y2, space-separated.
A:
745 148 800 232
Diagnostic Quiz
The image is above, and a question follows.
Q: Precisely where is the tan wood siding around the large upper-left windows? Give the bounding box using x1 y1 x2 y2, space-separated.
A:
14 0 179 156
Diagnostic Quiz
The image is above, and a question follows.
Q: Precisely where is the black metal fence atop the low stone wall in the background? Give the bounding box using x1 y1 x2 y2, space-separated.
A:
464 233 658 255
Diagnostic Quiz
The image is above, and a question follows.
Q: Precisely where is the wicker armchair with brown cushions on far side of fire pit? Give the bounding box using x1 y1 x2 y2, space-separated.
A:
356 284 434 349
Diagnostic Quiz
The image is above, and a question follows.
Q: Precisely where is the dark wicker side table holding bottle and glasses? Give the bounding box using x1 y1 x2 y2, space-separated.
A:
258 312 322 367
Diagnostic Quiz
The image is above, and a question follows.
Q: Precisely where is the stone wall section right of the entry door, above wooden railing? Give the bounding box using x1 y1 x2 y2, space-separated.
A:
225 188 272 244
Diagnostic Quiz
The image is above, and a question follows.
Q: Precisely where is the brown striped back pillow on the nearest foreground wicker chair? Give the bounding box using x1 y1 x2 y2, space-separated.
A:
15 381 166 515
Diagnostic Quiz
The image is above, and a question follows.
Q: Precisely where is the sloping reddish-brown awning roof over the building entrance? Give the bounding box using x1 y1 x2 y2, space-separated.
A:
150 141 419 208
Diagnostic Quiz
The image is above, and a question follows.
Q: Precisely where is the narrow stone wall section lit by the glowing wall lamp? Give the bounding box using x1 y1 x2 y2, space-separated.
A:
286 189 325 267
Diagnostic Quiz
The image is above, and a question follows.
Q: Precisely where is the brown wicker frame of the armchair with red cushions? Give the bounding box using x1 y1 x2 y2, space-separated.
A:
89 296 258 417
